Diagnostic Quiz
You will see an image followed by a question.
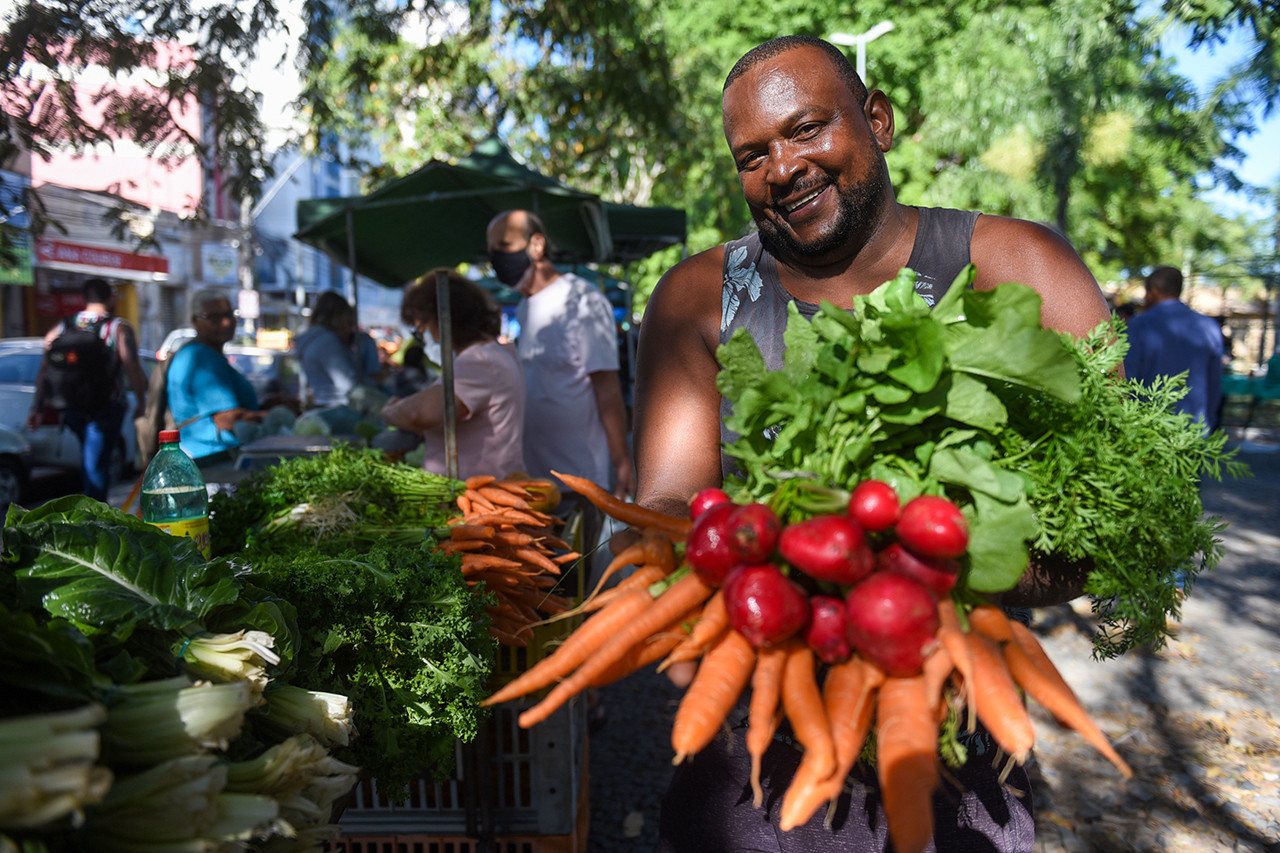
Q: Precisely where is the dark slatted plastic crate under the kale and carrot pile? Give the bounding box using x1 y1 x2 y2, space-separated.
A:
339 695 586 829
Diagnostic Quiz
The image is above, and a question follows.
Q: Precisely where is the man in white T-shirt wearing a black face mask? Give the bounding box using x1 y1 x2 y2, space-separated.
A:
486 210 636 512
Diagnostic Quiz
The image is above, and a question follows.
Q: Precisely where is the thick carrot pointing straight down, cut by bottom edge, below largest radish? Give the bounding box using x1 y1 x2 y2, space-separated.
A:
876 675 938 853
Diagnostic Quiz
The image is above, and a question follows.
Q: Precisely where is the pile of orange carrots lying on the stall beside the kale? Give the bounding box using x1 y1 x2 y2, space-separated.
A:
435 475 580 646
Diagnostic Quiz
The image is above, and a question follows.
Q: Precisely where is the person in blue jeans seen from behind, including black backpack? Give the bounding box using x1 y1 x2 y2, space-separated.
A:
27 278 147 501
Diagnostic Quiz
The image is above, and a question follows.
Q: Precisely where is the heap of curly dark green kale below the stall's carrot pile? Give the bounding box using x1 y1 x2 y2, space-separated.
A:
237 540 497 797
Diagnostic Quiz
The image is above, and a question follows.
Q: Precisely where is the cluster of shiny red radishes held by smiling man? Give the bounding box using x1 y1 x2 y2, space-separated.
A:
685 480 969 675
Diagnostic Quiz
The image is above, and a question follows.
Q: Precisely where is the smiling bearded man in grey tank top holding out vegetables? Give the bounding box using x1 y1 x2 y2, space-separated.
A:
635 36 1107 853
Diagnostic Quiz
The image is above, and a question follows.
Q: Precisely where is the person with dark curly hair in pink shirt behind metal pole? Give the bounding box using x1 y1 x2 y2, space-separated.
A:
381 269 526 479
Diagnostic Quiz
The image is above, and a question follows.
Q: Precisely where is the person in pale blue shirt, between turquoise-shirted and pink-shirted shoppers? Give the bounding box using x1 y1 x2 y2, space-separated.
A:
293 291 366 409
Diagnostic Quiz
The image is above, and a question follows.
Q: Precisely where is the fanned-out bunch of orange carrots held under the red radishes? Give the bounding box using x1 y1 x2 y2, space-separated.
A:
484 473 1132 853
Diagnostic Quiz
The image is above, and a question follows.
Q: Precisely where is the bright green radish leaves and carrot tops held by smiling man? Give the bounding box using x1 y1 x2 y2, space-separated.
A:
718 266 1228 654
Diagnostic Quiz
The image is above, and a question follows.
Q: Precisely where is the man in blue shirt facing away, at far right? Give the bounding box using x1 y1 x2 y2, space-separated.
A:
1124 266 1222 432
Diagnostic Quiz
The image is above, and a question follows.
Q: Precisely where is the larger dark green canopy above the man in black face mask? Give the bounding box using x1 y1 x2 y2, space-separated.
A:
294 138 612 287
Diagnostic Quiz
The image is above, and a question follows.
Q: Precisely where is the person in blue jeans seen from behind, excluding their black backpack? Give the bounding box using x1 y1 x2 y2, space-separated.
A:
27 278 147 501
